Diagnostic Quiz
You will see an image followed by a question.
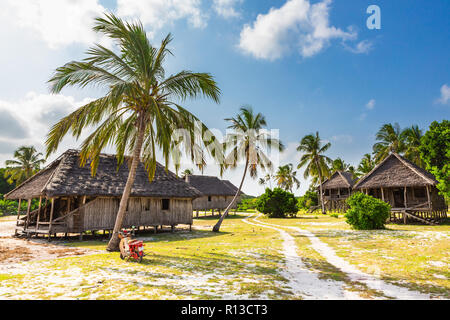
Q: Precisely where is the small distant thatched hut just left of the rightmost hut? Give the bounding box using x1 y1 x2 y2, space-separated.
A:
319 171 354 212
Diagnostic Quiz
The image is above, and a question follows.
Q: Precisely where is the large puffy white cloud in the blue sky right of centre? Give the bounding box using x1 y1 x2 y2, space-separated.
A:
239 0 357 60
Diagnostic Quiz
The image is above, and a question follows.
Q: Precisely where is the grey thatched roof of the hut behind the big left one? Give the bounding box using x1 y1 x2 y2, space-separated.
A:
187 175 238 196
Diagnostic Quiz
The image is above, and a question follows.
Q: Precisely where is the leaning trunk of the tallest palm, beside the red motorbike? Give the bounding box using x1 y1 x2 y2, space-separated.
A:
106 116 144 251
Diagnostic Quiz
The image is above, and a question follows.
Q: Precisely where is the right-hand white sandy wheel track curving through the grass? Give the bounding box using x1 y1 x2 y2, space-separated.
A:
253 216 431 300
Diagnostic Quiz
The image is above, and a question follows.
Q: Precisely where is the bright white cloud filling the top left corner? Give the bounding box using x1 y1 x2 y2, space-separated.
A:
0 0 105 49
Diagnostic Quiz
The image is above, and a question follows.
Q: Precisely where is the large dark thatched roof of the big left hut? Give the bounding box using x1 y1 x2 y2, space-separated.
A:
5 150 201 199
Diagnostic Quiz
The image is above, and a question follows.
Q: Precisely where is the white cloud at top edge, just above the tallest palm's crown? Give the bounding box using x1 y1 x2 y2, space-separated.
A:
117 0 208 35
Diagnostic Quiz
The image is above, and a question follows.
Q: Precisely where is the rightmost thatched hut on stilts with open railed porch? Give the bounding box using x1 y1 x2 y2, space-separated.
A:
353 153 447 223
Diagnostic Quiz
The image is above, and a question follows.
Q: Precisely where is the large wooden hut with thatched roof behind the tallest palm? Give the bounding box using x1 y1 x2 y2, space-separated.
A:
5 150 201 239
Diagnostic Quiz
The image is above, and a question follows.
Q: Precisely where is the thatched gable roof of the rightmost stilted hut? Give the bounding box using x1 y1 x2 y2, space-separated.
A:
354 153 438 189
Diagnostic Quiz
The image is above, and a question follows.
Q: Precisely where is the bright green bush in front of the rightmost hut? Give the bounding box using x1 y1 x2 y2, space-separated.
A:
345 192 391 230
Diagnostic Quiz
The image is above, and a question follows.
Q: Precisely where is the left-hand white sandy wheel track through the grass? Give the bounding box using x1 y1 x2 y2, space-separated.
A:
242 215 360 300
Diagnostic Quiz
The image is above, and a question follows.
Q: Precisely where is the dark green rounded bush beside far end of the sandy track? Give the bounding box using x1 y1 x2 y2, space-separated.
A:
256 188 298 218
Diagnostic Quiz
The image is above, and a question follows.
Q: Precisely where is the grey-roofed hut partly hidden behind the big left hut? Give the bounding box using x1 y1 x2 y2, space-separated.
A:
185 175 240 216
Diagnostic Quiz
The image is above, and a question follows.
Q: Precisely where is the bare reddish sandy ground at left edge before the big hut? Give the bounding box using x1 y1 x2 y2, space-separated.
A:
0 220 96 273
